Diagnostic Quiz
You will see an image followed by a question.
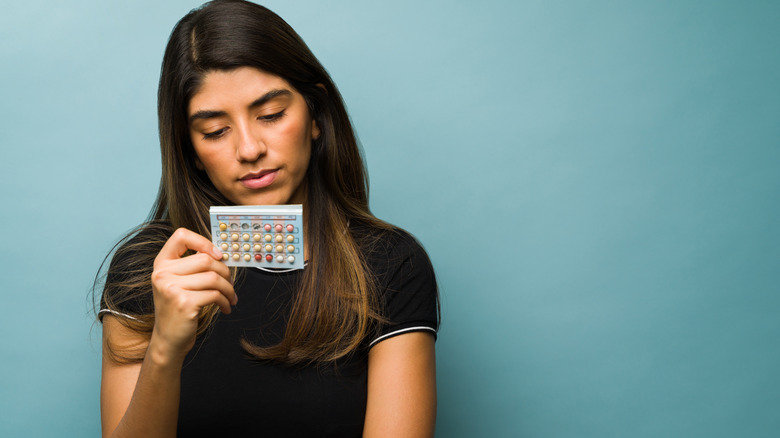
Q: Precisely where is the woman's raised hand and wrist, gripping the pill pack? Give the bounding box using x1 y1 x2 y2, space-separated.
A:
150 228 238 360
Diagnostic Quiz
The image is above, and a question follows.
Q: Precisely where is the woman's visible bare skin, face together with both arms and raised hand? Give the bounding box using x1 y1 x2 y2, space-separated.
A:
100 67 436 437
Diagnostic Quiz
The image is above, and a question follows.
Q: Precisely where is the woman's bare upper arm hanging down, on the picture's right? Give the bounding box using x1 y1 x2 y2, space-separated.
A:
363 332 436 438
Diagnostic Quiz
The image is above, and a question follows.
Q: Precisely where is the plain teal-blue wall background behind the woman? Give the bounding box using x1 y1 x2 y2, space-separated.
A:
0 0 780 437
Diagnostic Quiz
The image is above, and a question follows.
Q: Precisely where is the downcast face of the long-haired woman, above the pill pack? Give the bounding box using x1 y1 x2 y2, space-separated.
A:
187 67 320 205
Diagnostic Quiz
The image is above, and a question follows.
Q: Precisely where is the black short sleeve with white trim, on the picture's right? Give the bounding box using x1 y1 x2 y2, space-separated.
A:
369 231 439 347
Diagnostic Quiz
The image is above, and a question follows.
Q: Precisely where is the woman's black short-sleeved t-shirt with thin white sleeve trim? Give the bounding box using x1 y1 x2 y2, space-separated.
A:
102 224 438 437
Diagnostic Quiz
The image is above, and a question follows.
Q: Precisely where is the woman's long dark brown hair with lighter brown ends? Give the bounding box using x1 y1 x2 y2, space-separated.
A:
101 0 393 363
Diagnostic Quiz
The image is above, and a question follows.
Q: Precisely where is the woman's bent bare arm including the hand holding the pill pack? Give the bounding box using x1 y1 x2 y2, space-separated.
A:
100 229 233 438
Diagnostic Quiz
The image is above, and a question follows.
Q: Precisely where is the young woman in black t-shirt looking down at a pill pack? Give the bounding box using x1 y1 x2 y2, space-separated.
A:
99 1 438 437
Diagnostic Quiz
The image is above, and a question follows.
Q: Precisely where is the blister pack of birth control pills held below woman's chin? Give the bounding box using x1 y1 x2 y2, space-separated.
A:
209 204 304 270
